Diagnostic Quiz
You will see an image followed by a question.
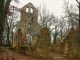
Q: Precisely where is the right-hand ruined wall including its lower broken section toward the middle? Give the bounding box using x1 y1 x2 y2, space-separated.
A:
51 28 80 57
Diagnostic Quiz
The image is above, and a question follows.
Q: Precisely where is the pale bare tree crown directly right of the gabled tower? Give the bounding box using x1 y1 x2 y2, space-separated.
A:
38 5 55 29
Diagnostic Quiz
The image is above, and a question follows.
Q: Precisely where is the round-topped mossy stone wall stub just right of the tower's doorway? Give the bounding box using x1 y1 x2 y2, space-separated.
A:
36 28 51 57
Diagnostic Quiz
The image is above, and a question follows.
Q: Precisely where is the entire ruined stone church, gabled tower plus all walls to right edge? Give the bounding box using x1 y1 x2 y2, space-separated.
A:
12 3 80 57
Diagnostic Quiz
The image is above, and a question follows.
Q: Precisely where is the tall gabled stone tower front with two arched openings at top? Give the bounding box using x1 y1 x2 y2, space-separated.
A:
13 3 41 46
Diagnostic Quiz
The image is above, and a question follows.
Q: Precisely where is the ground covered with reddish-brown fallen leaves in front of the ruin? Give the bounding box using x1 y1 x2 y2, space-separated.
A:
0 49 80 60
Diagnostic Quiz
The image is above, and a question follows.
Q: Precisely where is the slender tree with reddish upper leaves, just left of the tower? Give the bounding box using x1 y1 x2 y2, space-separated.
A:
4 0 19 46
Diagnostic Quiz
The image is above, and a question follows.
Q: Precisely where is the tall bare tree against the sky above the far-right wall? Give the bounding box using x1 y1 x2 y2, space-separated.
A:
63 0 76 29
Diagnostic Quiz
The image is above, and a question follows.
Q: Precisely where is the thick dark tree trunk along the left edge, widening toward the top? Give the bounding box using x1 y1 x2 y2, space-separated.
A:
0 0 11 44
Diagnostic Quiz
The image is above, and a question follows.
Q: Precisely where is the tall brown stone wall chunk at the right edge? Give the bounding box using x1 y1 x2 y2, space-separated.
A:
64 28 80 57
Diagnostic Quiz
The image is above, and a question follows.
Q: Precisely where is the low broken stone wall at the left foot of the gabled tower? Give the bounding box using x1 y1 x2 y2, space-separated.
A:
12 29 27 47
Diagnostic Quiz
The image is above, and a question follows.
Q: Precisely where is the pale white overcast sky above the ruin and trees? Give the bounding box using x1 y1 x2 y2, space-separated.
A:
11 0 77 17
